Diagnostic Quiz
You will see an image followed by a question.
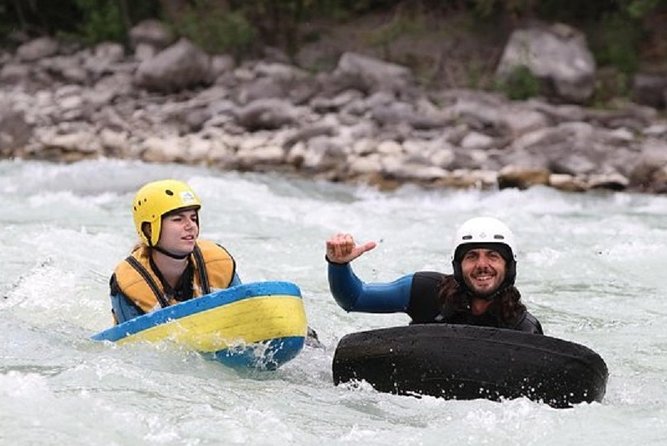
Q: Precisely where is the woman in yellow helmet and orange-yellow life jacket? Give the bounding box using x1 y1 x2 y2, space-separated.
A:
110 180 241 323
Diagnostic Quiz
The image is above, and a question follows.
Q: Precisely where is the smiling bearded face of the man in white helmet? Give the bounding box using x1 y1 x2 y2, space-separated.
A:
461 248 507 297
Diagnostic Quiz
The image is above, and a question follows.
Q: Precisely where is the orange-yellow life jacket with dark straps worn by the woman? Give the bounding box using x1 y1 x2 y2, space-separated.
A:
114 240 236 313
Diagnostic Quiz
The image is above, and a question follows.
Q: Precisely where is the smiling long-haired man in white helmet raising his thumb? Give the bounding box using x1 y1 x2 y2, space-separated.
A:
326 217 543 334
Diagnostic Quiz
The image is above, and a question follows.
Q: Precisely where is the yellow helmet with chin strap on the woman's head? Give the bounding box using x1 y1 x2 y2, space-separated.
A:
132 180 201 246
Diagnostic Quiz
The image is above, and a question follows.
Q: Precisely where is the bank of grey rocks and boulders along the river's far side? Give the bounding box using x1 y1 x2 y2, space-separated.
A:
0 23 667 193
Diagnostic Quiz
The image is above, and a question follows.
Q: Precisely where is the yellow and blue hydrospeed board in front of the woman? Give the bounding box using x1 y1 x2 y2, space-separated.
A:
92 282 308 370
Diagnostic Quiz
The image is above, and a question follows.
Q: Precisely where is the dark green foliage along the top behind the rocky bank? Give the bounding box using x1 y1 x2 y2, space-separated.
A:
0 0 667 85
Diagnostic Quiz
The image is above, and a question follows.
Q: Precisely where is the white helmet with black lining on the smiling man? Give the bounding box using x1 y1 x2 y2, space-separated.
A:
452 217 517 286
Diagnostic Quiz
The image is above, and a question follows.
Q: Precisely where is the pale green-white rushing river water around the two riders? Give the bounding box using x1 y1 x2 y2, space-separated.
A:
0 160 667 446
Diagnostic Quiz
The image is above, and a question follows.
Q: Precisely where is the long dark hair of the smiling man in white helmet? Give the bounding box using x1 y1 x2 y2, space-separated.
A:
438 276 526 326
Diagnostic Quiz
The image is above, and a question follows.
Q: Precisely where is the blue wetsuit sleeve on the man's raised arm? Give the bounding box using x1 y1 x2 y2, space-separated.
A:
328 263 413 313
